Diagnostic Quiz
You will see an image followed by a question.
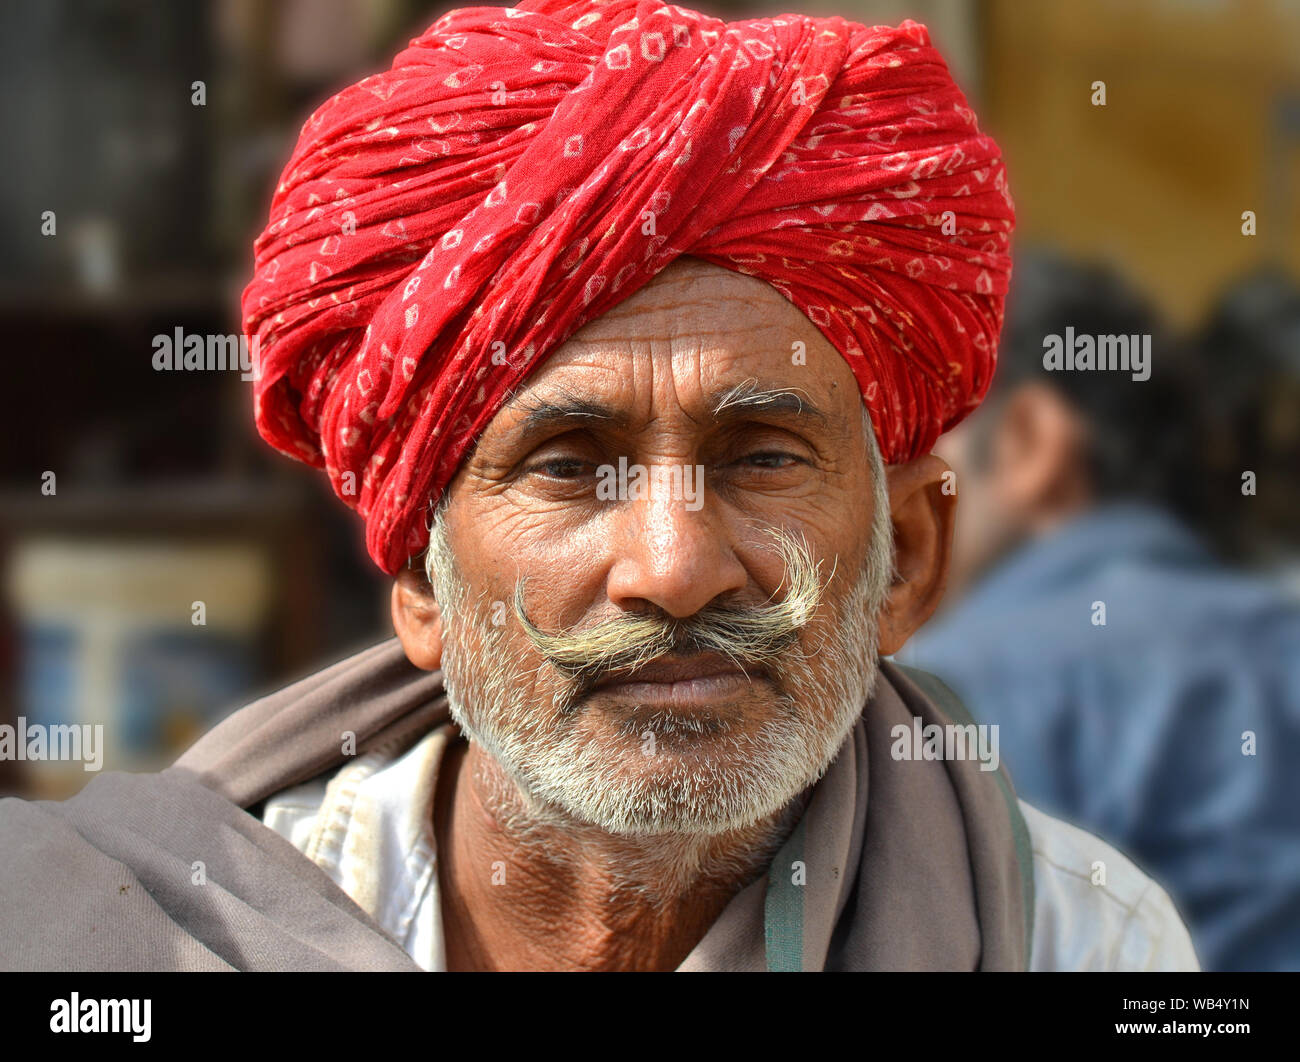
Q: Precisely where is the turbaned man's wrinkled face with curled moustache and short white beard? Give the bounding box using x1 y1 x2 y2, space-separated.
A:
430 260 889 833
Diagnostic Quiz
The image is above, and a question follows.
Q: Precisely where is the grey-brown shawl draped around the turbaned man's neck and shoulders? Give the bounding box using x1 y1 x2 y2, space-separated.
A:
0 640 1032 971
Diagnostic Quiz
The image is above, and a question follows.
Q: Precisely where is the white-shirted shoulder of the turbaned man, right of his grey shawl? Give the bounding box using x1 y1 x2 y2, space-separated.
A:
1019 801 1200 971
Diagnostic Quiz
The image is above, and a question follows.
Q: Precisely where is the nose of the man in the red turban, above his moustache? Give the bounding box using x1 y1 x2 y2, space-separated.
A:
607 475 749 619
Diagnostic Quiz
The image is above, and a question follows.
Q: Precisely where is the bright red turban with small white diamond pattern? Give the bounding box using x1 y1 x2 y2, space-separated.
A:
243 0 1013 573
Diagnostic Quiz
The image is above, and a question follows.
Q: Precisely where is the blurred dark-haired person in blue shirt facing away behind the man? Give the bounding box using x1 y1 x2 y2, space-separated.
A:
900 251 1300 970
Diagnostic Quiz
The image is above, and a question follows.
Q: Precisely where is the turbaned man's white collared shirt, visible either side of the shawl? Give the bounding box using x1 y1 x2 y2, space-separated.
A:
263 725 1200 971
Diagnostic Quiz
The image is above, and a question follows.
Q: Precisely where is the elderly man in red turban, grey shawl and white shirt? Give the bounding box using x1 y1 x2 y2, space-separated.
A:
0 0 1196 970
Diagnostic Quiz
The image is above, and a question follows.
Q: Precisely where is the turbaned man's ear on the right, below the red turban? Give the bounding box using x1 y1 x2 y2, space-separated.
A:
879 454 957 656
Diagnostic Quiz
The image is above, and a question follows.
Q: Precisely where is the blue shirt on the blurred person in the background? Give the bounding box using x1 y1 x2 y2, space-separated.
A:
898 504 1300 970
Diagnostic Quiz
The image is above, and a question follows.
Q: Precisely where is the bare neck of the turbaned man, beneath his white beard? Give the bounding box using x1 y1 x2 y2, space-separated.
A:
434 740 811 970
